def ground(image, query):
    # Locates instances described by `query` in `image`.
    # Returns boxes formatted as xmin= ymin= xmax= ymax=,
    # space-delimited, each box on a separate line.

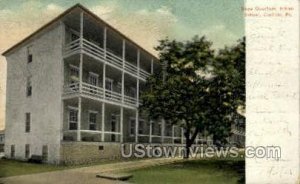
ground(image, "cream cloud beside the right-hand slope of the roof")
xmin=91 ymin=4 xmax=178 ymax=54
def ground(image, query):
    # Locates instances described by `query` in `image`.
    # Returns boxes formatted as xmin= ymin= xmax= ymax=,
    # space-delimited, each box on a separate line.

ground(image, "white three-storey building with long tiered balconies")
xmin=3 ymin=4 xmax=211 ymax=163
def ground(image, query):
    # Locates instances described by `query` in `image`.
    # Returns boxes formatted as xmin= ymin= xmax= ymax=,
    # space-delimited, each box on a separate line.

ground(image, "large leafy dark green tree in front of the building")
xmin=141 ymin=36 xmax=246 ymax=158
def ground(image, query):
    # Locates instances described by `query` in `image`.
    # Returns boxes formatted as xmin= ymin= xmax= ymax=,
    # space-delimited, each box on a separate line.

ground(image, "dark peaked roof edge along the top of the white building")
xmin=2 ymin=3 xmax=157 ymax=59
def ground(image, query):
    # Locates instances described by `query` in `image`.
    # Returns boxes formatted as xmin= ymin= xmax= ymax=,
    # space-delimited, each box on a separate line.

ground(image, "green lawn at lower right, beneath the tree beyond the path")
xmin=129 ymin=159 xmax=245 ymax=184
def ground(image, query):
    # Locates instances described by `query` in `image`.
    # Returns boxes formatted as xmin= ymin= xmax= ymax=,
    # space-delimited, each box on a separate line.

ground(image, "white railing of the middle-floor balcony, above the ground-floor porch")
xmin=64 ymin=82 xmax=137 ymax=107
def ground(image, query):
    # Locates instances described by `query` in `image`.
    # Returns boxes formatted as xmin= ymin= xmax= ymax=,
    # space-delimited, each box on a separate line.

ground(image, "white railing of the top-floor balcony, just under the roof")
xmin=64 ymin=39 xmax=150 ymax=80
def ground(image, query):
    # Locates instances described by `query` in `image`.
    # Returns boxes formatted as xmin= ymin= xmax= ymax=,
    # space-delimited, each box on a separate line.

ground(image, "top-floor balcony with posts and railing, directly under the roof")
xmin=63 ymin=11 xmax=161 ymax=81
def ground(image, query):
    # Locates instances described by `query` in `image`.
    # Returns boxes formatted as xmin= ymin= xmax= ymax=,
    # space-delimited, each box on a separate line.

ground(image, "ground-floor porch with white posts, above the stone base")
xmin=62 ymin=97 xmax=209 ymax=144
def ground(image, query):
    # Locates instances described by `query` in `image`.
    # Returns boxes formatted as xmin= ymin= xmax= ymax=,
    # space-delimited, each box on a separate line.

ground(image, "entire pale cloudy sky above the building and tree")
xmin=0 ymin=0 xmax=244 ymax=130
